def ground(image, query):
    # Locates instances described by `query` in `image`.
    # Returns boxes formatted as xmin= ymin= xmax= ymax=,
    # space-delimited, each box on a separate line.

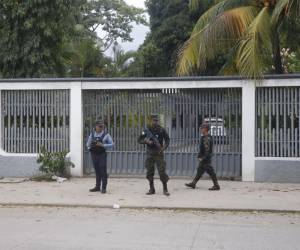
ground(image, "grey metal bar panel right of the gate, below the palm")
xmin=256 ymin=87 xmax=300 ymax=157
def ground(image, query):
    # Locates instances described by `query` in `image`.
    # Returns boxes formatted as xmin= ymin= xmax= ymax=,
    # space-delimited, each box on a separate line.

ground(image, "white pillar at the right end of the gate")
xmin=242 ymin=81 xmax=255 ymax=181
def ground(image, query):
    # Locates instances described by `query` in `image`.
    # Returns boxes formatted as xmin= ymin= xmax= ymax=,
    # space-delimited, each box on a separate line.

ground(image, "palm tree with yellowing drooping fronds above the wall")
xmin=177 ymin=0 xmax=300 ymax=79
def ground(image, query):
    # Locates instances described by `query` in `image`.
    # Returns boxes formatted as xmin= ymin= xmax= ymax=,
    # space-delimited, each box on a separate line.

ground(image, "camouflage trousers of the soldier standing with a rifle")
xmin=145 ymin=154 xmax=169 ymax=183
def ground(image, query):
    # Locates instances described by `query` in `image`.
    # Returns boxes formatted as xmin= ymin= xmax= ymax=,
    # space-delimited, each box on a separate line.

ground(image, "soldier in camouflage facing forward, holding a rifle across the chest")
xmin=138 ymin=115 xmax=170 ymax=196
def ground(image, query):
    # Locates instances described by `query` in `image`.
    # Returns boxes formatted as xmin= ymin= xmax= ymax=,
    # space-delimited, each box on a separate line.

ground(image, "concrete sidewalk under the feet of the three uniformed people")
xmin=0 ymin=178 xmax=300 ymax=212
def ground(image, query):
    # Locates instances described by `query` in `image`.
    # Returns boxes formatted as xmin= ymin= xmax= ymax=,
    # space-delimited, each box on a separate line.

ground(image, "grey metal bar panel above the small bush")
xmin=1 ymin=90 xmax=70 ymax=153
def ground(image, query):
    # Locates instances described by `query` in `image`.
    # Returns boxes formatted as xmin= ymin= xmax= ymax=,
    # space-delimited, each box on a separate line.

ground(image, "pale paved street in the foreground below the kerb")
xmin=0 ymin=207 xmax=300 ymax=250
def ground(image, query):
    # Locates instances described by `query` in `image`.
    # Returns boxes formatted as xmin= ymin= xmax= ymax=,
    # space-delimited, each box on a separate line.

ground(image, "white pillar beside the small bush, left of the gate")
xmin=70 ymin=82 xmax=83 ymax=176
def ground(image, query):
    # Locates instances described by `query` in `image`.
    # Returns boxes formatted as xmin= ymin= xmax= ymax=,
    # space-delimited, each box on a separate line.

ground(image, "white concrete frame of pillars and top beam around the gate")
xmin=0 ymin=76 xmax=300 ymax=181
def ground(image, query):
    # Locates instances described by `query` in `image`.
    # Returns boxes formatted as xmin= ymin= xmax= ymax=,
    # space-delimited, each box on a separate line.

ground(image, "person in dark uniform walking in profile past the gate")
xmin=185 ymin=123 xmax=220 ymax=191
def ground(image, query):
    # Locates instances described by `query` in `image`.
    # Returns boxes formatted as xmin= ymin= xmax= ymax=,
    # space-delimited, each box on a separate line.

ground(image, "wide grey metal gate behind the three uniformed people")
xmin=83 ymin=88 xmax=242 ymax=178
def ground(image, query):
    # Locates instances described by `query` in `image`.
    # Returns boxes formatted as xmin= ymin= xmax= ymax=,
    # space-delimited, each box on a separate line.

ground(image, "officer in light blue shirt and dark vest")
xmin=86 ymin=120 xmax=114 ymax=194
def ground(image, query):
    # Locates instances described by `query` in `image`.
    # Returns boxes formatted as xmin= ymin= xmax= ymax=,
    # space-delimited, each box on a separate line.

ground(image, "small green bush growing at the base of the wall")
xmin=37 ymin=148 xmax=74 ymax=177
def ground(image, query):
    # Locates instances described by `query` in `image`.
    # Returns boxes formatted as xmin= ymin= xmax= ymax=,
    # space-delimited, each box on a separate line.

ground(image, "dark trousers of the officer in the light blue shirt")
xmin=91 ymin=153 xmax=108 ymax=189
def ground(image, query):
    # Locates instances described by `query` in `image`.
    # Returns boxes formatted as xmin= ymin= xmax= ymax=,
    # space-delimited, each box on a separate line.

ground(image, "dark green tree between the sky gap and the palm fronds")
xmin=136 ymin=0 xmax=206 ymax=77
